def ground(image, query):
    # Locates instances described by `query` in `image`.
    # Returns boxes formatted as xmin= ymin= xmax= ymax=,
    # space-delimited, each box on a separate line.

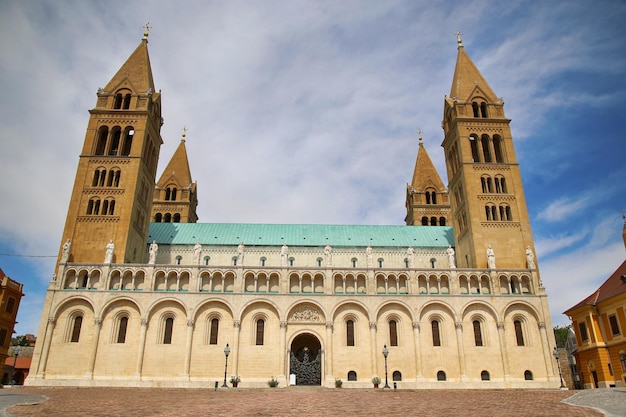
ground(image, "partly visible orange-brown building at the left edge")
xmin=0 ymin=269 xmax=24 ymax=376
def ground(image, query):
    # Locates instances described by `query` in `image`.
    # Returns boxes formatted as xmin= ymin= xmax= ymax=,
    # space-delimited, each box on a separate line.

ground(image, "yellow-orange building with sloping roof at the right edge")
xmin=564 ymin=219 xmax=626 ymax=388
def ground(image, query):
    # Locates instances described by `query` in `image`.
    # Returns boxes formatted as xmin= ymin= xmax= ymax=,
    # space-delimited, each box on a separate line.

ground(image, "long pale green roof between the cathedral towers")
xmin=148 ymin=223 xmax=454 ymax=248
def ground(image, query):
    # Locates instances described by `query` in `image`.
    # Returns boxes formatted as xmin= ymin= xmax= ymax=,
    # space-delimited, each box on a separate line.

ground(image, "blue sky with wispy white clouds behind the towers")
xmin=0 ymin=0 xmax=626 ymax=334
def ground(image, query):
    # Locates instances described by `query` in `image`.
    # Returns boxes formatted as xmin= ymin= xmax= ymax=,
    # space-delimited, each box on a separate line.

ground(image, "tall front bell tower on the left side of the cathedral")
xmin=59 ymin=30 xmax=163 ymax=263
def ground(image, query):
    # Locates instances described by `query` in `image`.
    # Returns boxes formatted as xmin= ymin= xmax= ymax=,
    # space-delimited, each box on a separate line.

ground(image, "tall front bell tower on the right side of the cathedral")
xmin=442 ymin=33 xmax=534 ymax=269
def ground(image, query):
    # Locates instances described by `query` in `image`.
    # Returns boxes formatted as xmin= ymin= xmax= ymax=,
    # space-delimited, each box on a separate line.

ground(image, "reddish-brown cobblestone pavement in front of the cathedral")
xmin=0 ymin=387 xmax=626 ymax=417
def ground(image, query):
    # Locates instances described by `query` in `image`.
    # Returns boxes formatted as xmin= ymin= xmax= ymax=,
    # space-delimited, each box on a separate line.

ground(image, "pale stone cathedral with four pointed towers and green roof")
xmin=26 ymin=33 xmax=559 ymax=389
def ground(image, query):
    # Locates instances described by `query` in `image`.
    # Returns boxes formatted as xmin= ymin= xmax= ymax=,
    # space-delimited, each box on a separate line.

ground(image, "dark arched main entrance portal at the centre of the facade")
xmin=289 ymin=333 xmax=322 ymax=385
